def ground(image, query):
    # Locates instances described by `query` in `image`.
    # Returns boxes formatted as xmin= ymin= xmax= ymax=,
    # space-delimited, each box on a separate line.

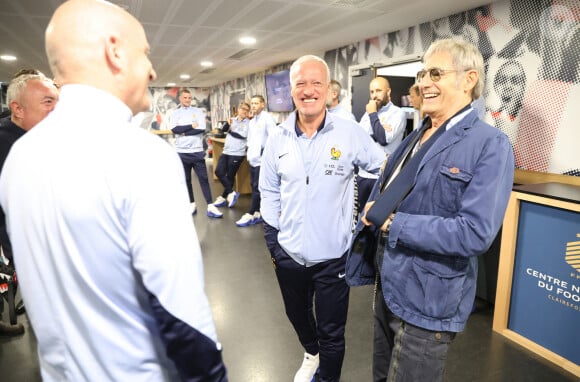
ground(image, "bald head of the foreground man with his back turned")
xmin=46 ymin=0 xmax=156 ymax=114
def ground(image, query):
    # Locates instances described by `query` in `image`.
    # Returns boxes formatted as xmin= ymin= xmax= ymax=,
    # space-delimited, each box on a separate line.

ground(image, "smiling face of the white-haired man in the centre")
xmin=291 ymin=61 xmax=330 ymax=120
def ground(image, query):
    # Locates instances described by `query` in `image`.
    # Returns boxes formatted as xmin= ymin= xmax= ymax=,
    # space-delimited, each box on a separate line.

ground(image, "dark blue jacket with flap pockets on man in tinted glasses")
xmin=347 ymin=110 xmax=514 ymax=332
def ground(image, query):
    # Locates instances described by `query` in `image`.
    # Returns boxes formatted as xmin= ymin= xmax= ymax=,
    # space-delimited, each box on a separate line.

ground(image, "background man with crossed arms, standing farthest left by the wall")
xmin=169 ymin=89 xmax=222 ymax=218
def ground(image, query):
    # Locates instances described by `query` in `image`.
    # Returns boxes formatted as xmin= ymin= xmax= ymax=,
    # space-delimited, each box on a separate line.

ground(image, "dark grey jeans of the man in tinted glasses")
xmin=373 ymin=283 xmax=456 ymax=382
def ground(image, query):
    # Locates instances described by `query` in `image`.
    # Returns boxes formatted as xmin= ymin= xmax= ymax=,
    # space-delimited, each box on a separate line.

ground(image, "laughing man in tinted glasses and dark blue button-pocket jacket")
xmin=347 ymin=39 xmax=514 ymax=381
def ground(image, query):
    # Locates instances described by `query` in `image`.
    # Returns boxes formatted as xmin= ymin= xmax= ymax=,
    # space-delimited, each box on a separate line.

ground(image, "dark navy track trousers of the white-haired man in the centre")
xmin=270 ymin=245 xmax=350 ymax=382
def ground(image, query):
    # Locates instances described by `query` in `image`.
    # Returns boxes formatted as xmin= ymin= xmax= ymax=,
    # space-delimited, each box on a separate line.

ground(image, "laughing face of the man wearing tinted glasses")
xmin=419 ymin=51 xmax=477 ymax=123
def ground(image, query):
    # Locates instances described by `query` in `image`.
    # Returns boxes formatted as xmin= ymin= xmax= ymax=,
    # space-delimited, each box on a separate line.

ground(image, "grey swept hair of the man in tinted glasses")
xmin=423 ymin=38 xmax=485 ymax=99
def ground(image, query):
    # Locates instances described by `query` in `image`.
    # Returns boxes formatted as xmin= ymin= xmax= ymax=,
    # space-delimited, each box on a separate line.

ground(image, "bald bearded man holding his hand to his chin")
xmin=356 ymin=77 xmax=407 ymax=215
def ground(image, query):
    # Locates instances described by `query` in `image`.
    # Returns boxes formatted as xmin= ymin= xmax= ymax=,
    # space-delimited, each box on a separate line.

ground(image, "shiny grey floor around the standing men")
xmin=0 ymin=163 xmax=578 ymax=382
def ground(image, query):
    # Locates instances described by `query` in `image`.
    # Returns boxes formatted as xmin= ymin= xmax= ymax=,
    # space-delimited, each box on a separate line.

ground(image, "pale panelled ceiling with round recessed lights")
xmin=0 ymin=0 xmax=492 ymax=87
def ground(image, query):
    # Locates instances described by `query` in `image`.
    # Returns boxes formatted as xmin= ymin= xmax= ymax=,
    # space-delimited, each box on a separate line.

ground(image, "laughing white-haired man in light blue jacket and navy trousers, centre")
xmin=260 ymin=55 xmax=385 ymax=382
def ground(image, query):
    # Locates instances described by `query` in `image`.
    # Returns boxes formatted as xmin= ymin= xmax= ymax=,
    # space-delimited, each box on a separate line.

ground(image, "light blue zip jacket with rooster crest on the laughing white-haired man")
xmin=260 ymin=113 xmax=385 ymax=266
